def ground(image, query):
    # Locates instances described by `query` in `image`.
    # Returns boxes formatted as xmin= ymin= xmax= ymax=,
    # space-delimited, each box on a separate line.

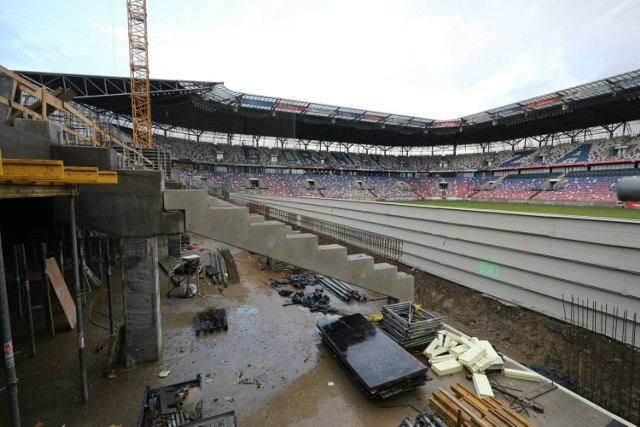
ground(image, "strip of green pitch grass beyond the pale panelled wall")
xmin=406 ymin=200 xmax=640 ymax=221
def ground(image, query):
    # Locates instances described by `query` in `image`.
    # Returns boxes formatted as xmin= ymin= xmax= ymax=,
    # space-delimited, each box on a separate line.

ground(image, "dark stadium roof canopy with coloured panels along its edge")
xmin=16 ymin=69 xmax=640 ymax=147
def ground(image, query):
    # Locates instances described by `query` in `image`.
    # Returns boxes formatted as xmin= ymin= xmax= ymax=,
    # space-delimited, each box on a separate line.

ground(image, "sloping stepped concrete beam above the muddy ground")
xmin=164 ymin=190 xmax=414 ymax=301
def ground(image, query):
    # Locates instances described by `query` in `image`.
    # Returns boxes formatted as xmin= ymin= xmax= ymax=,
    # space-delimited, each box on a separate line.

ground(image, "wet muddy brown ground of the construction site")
xmin=0 ymin=231 xmax=640 ymax=426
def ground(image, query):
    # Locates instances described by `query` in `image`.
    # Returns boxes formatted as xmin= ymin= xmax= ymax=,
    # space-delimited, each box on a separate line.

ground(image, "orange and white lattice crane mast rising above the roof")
xmin=127 ymin=0 xmax=153 ymax=148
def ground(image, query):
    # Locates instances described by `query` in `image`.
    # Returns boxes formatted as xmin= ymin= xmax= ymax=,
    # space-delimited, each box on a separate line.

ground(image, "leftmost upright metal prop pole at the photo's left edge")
xmin=0 ymin=236 xmax=20 ymax=427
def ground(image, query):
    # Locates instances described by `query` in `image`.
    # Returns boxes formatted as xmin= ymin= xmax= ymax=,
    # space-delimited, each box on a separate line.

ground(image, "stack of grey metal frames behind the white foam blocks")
xmin=379 ymin=302 xmax=442 ymax=349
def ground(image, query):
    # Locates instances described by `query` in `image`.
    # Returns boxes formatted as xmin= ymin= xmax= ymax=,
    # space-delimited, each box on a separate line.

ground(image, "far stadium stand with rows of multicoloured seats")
xmin=166 ymin=135 xmax=640 ymax=203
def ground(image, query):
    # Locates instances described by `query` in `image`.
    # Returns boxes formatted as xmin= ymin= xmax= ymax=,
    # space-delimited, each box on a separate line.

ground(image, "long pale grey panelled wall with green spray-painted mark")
xmin=237 ymin=195 xmax=640 ymax=342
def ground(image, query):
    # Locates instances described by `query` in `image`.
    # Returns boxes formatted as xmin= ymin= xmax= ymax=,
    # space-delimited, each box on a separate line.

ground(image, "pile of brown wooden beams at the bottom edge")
xmin=429 ymin=384 xmax=533 ymax=427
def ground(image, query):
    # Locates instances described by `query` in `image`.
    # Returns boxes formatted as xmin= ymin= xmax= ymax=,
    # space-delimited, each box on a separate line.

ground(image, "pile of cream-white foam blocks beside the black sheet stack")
xmin=422 ymin=330 xmax=504 ymax=375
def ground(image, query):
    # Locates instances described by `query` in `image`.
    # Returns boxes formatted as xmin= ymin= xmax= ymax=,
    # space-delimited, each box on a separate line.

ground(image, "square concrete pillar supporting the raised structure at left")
xmin=121 ymin=237 xmax=162 ymax=367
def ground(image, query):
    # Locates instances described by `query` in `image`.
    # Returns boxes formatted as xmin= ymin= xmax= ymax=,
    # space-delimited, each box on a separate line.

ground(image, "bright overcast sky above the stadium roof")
xmin=0 ymin=0 xmax=640 ymax=119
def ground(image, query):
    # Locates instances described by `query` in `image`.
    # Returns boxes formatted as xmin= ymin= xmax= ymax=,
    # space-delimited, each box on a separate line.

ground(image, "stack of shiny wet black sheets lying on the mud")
xmin=317 ymin=313 xmax=429 ymax=399
